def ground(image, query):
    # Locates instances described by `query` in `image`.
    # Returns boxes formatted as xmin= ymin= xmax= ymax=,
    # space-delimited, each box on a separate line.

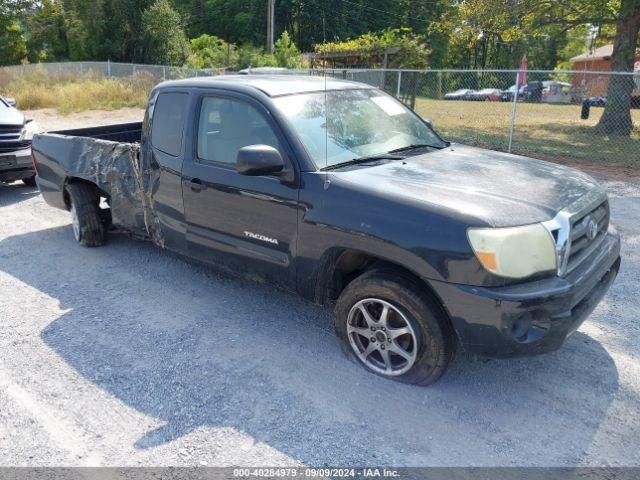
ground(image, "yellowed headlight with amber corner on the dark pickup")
xmin=467 ymin=223 xmax=557 ymax=278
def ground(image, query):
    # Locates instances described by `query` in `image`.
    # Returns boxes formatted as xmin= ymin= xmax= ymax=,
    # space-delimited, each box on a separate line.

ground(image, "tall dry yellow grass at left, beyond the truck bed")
xmin=0 ymin=69 xmax=158 ymax=114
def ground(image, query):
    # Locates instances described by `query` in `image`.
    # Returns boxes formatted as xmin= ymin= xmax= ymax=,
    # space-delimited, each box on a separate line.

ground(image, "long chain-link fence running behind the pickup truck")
xmin=0 ymin=62 xmax=640 ymax=167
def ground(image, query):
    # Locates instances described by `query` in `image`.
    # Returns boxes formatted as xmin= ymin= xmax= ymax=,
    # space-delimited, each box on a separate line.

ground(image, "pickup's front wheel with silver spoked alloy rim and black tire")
xmin=334 ymin=269 xmax=456 ymax=385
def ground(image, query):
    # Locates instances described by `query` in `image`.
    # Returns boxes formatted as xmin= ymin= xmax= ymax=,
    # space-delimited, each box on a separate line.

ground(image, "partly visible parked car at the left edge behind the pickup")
xmin=0 ymin=97 xmax=38 ymax=187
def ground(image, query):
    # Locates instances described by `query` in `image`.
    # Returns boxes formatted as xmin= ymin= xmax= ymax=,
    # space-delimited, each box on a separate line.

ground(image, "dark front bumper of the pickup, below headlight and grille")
xmin=433 ymin=232 xmax=620 ymax=358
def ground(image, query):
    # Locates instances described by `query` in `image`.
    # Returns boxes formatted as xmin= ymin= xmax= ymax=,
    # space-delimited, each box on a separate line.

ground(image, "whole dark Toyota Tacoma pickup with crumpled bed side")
xmin=33 ymin=76 xmax=620 ymax=385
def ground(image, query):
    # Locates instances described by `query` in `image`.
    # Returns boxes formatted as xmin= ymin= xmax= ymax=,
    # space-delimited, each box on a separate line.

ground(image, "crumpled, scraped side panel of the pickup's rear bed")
xmin=33 ymin=123 xmax=163 ymax=246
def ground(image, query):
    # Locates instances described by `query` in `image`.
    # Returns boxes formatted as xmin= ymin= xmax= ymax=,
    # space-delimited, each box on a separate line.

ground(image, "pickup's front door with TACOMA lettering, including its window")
xmin=182 ymin=95 xmax=298 ymax=288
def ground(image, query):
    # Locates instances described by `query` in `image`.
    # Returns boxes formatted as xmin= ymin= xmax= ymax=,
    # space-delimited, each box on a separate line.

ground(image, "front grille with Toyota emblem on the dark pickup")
xmin=566 ymin=200 xmax=609 ymax=273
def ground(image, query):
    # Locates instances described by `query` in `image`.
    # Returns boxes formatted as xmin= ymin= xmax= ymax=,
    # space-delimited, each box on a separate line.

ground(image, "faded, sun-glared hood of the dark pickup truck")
xmin=336 ymin=144 xmax=600 ymax=227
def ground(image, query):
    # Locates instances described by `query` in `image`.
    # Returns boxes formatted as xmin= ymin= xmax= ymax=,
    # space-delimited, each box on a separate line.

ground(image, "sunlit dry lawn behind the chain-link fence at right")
xmin=416 ymin=98 xmax=640 ymax=168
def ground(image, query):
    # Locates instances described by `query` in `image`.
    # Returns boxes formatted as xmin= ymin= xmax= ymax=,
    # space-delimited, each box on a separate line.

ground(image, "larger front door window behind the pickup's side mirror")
xmin=198 ymin=97 xmax=282 ymax=164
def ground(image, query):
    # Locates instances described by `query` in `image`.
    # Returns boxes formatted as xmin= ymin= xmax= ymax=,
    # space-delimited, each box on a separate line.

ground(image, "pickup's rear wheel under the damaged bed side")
xmin=67 ymin=183 xmax=105 ymax=247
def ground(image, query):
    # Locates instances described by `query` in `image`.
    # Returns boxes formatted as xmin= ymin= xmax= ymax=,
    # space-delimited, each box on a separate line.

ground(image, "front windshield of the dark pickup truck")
xmin=274 ymin=89 xmax=446 ymax=168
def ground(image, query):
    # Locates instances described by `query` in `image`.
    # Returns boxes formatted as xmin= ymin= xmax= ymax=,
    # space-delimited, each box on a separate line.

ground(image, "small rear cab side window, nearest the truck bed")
xmin=151 ymin=93 xmax=189 ymax=157
